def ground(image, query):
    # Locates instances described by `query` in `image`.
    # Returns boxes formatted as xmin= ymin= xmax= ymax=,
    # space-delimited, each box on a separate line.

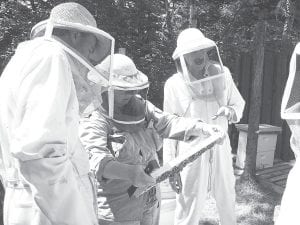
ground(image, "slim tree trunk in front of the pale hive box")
xmin=242 ymin=19 xmax=266 ymax=180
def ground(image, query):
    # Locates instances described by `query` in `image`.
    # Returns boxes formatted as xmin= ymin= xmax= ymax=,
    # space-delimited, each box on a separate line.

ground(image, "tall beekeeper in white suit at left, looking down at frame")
xmin=0 ymin=2 xmax=114 ymax=225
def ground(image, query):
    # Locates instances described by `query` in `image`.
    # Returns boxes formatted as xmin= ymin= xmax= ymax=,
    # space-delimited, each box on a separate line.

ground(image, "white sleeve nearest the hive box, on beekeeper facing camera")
xmin=226 ymin=68 xmax=245 ymax=123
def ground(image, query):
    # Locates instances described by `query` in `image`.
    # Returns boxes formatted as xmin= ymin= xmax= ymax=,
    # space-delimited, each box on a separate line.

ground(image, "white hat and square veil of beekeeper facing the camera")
xmin=172 ymin=28 xmax=225 ymax=100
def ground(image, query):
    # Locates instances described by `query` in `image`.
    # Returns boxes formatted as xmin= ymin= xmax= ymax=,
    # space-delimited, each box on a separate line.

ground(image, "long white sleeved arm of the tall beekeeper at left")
xmin=11 ymin=51 xmax=92 ymax=225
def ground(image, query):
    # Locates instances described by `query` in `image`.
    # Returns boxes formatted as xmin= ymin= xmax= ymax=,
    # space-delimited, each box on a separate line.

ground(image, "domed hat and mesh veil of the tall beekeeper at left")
xmin=30 ymin=3 xmax=115 ymax=114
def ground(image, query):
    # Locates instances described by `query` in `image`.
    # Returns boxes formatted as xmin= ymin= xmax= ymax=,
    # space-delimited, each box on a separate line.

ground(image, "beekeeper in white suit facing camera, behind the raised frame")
xmin=163 ymin=28 xmax=245 ymax=225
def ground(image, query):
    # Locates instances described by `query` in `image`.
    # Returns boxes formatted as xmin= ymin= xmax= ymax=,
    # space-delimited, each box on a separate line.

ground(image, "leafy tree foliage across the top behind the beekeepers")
xmin=0 ymin=0 xmax=300 ymax=107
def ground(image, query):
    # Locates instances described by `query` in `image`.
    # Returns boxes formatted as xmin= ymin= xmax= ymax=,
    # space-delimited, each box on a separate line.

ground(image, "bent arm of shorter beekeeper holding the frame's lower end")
xmin=80 ymin=110 xmax=155 ymax=187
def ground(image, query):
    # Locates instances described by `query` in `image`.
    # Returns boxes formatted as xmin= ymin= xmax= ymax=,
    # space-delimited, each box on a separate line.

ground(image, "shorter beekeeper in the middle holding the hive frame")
xmin=80 ymin=54 xmax=224 ymax=225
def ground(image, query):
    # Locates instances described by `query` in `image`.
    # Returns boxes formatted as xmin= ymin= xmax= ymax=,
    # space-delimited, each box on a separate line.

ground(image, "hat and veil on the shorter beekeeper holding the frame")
xmin=88 ymin=54 xmax=149 ymax=130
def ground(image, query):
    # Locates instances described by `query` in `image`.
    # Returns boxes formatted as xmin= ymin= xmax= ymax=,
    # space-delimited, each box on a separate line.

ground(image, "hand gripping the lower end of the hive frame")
xmin=129 ymin=165 xmax=156 ymax=187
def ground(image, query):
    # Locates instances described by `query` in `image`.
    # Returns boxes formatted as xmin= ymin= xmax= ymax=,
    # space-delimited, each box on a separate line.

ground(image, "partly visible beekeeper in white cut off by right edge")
xmin=275 ymin=43 xmax=300 ymax=225
